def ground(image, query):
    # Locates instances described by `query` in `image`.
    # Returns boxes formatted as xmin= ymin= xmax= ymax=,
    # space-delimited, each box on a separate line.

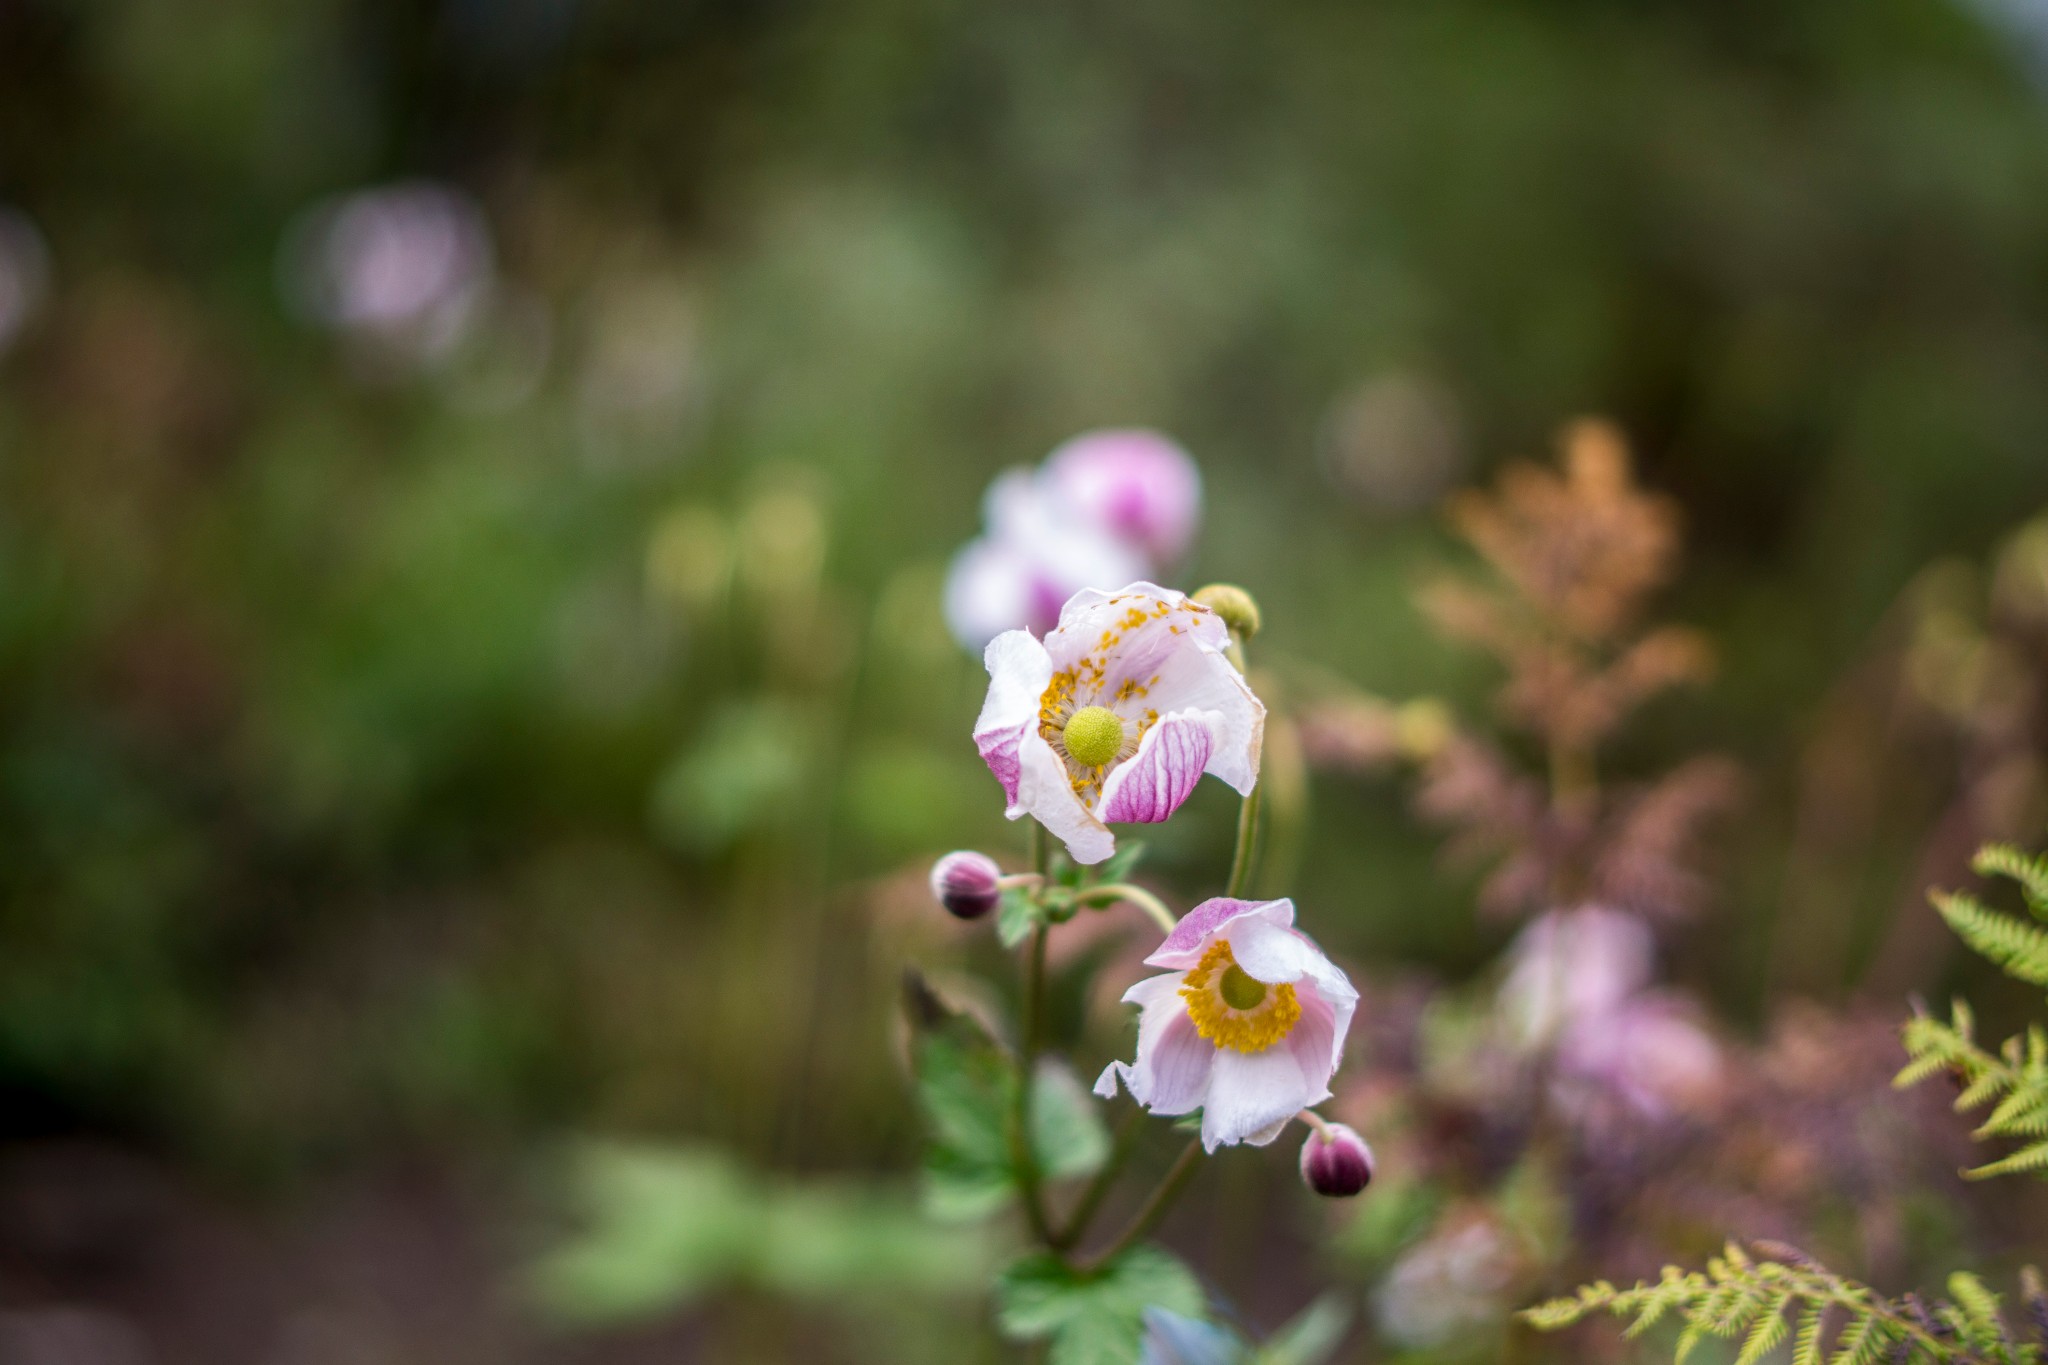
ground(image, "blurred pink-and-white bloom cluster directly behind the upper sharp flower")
xmin=946 ymin=428 xmax=1202 ymax=651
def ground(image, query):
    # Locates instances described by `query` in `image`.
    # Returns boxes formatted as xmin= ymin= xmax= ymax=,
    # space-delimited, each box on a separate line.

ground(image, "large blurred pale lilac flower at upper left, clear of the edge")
xmin=283 ymin=180 xmax=492 ymax=362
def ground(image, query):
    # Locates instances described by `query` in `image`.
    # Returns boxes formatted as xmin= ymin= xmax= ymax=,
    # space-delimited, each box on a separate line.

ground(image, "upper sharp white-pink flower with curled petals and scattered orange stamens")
xmin=975 ymin=583 xmax=1266 ymax=864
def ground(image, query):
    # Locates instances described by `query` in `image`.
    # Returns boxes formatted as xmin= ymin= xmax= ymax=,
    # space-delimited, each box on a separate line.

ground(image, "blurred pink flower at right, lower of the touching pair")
xmin=1552 ymin=993 xmax=1722 ymax=1121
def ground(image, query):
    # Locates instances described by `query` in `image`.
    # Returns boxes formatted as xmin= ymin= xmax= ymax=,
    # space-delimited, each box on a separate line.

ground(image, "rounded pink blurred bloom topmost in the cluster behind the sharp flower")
xmin=1042 ymin=428 xmax=1202 ymax=571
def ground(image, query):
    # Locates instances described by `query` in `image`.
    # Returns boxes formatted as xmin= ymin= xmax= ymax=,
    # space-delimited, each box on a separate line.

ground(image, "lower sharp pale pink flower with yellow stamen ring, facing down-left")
xmin=1096 ymin=898 xmax=1358 ymax=1152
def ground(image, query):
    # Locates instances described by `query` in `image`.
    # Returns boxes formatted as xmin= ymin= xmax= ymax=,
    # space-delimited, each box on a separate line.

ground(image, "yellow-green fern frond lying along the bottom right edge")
xmin=1522 ymin=1244 xmax=2048 ymax=1365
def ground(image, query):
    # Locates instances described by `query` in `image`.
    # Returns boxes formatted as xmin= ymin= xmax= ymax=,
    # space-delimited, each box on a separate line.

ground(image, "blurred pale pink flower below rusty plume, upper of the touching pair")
xmin=1499 ymin=905 xmax=1655 ymax=1048
